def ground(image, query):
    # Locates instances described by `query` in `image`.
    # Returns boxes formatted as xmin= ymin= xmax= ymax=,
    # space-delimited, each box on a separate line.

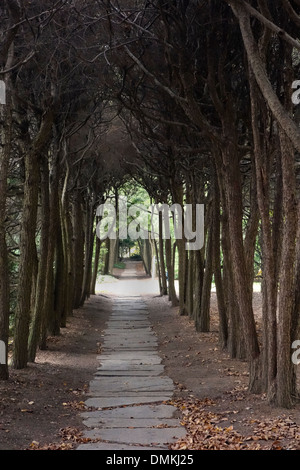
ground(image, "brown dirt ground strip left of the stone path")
xmin=0 ymin=295 xmax=111 ymax=450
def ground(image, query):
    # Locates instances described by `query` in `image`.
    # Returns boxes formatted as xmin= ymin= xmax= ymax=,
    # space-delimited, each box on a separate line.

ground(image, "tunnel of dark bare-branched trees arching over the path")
xmin=0 ymin=0 xmax=300 ymax=408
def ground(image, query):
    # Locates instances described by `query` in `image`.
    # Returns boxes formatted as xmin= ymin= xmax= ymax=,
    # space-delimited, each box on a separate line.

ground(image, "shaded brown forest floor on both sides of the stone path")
xmin=0 ymin=262 xmax=300 ymax=450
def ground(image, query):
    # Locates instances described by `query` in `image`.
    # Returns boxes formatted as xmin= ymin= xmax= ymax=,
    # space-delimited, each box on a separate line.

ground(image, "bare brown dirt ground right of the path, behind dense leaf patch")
xmin=147 ymin=293 xmax=300 ymax=450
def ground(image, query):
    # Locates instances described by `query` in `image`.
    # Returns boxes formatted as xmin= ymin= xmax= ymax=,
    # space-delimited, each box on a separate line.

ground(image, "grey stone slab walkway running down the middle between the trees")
xmin=78 ymin=265 xmax=186 ymax=450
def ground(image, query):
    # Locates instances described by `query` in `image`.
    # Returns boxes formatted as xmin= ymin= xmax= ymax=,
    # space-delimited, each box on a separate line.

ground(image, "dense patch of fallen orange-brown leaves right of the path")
xmin=170 ymin=398 xmax=300 ymax=450
